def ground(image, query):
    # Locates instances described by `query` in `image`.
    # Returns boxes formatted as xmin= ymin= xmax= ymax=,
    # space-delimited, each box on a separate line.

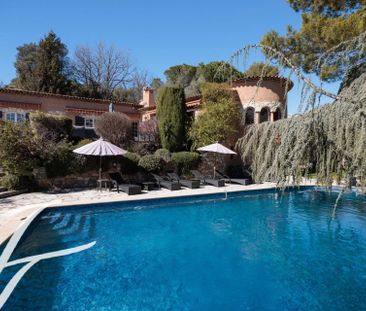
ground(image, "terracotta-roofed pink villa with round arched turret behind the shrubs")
xmin=0 ymin=76 xmax=293 ymax=138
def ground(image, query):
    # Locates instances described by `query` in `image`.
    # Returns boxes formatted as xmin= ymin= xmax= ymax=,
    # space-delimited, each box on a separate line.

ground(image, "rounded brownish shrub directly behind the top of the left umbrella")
xmin=95 ymin=112 xmax=132 ymax=147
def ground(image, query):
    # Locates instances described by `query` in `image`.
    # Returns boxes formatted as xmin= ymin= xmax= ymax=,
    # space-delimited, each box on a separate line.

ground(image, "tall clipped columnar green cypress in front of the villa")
xmin=157 ymin=86 xmax=188 ymax=151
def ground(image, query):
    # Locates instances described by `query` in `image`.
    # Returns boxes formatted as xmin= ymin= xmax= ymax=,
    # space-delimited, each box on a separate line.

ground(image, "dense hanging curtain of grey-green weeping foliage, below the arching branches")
xmin=236 ymin=91 xmax=366 ymax=187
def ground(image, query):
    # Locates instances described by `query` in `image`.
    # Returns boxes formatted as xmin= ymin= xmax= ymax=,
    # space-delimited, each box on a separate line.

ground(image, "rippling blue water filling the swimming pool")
xmin=0 ymin=190 xmax=366 ymax=311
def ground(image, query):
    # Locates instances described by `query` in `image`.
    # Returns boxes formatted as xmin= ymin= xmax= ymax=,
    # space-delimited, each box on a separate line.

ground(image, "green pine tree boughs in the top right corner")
xmin=261 ymin=0 xmax=366 ymax=81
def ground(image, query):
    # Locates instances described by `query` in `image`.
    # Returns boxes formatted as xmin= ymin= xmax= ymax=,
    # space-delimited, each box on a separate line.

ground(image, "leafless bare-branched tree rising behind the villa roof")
xmin=73 ymin=43 xmax=135 ymax=99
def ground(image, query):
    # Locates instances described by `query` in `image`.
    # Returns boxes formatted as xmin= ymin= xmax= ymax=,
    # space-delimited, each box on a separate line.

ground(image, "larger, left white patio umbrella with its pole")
xmin=73 ymin=138 xmax=127 ymax=179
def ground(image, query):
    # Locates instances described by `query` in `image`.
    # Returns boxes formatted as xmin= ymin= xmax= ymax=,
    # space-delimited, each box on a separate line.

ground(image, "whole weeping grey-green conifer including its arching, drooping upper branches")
xmin=220 ymin=33 xmax=366 ymax=193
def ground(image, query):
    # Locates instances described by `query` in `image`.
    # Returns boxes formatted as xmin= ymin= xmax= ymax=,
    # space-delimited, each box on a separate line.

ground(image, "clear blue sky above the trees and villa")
xmin=0 ymin=0 xmax=338 ymax=113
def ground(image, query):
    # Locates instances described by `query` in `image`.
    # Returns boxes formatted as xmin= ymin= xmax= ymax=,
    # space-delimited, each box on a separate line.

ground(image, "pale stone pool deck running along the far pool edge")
xmin=0 ymin=183 xmax=312 ymax=244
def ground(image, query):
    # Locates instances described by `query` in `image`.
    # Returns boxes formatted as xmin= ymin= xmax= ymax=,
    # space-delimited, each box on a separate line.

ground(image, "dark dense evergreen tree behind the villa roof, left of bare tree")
xmin=11 ymin=31 xmax=70 ymax=94
